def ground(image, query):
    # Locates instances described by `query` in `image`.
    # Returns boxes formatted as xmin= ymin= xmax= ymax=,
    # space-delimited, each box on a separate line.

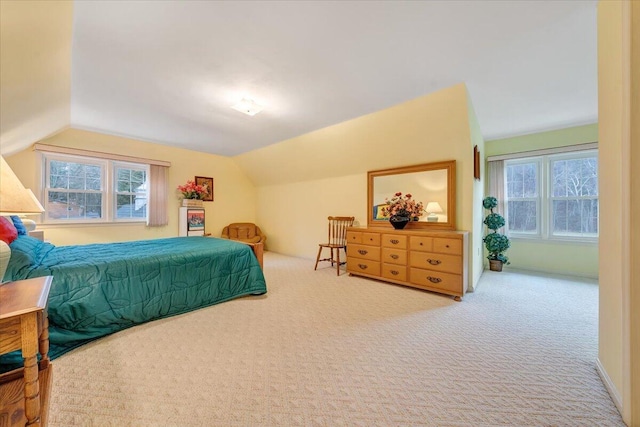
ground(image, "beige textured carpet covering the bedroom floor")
xmin=49 ymin=252 xmax=624 ymax=427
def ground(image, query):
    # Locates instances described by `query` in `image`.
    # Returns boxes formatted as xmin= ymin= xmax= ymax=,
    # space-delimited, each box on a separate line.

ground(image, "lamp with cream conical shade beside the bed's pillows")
xmin=0 ymin=156 xmax=44 ymax=282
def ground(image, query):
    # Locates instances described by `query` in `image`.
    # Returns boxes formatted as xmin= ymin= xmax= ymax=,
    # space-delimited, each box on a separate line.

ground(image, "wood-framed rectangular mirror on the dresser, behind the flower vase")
xmin=367 ymin=160 xmax=456 ymax=230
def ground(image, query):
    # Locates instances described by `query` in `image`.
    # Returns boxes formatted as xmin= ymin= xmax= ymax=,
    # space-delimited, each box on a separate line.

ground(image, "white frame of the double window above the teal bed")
xmin=40 ymin=152 xmax=150 ymax=225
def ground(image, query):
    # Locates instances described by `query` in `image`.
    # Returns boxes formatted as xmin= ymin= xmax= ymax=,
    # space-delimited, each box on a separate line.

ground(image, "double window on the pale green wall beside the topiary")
xmin=504 ymin=150 xmax=598 ymax=240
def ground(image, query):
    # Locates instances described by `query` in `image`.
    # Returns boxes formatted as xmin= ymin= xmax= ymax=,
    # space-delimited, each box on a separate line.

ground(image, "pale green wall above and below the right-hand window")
xmin=485 ymin=124 xmax=605 ymax=278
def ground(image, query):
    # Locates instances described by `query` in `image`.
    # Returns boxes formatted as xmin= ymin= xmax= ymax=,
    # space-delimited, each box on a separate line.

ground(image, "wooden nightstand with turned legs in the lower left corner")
xmin=0 ymin=276 xmax=53 ymax=427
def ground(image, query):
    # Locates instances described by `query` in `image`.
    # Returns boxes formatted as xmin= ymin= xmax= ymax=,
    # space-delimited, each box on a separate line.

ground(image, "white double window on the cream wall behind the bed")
xmin=44 ymin=154 xmax=149 ymax=223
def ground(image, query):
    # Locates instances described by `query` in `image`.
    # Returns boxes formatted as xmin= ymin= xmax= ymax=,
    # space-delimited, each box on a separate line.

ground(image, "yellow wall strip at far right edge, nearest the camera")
xmin=598 ymin=1 xmax=640 ymax=426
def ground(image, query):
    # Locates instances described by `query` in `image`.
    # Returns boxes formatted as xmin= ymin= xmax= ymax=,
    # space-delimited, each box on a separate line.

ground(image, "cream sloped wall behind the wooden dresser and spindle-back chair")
xmin=234 ymin=84 xmax=479 ymax=285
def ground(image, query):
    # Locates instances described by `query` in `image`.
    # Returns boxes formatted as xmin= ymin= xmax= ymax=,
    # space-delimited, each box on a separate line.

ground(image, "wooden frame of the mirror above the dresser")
xmin=367 ymin=160 xmax=457 ymax=230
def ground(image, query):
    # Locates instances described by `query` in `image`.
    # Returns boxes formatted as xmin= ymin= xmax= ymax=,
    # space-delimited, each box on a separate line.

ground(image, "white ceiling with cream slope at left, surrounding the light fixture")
xmin=0 ymin=0 xmax=597 ymax=155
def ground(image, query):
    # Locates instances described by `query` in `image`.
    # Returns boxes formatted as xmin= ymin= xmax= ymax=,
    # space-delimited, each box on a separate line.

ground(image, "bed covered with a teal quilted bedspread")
xmin=0 ymin=235 xmax=267 ymax=372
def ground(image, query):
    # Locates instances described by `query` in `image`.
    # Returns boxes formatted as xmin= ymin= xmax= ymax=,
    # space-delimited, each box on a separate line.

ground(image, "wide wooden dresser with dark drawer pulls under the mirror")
xmin=347 ymin=226 xmax=469 ymax=301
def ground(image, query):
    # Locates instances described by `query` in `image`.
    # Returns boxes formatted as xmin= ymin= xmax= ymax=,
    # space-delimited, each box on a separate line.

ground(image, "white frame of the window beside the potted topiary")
xmin=503 ymin=148 xmax=600 ymax=244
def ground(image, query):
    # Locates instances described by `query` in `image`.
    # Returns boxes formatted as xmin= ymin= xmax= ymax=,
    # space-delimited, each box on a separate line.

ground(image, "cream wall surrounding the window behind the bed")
xmin=6 ymin=129 xmax=256 ymax=245
